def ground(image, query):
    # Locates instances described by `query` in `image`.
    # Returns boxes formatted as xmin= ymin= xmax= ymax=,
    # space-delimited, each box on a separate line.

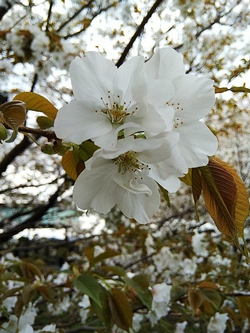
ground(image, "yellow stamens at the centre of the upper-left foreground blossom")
xmin=96 ymin=90 xmax=138 ymax=124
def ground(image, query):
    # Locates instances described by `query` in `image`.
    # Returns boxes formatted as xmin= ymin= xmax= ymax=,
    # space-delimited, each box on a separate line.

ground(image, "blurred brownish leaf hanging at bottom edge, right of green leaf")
xmin=109 ymin=288 xmax=133 ymax=332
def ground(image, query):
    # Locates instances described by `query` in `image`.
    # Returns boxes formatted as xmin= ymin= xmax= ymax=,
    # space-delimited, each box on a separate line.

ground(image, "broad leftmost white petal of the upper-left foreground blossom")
xmin=54 ymin=100 xmax=112 ymax=144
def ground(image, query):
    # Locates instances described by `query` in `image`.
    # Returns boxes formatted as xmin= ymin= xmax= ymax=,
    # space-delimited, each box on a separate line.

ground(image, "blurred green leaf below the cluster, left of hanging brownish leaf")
xmin=73 ymin=274 xmax=101 ymax=306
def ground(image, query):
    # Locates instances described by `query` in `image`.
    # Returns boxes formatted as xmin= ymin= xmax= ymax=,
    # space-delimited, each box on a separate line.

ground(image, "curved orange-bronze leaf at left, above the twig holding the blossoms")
xmin=14 ymin=92 xmax=58 ymax=120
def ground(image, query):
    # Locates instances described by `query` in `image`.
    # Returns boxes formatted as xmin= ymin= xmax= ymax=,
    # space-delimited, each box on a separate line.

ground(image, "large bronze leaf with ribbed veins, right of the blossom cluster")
xmin=200 ymin=158 xmax=249 ymax=246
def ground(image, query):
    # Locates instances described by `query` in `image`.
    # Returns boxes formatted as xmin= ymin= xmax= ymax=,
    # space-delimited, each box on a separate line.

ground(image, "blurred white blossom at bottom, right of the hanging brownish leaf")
xmin=149 ymin=283 xmax=172 ymax=325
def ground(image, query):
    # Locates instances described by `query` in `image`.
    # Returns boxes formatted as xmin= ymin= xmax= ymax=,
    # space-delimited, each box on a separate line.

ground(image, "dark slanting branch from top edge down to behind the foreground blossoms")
xmin=116 ymin=0 xmax=164 ymax=67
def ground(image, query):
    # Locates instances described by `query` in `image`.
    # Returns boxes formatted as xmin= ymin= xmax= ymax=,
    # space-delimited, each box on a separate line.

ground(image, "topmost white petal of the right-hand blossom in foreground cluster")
xmin=145 ymin=47 xmax=185 ymax=81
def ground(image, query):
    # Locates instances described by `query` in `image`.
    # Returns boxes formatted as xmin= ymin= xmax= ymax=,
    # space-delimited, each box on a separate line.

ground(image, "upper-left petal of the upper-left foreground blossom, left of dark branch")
xmin=70 ymin=51 xmax=117 ymax=102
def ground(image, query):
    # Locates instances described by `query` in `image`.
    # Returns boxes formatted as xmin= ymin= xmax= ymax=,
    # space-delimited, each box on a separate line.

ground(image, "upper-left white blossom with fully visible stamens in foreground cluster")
xmin=55 ymin=52 xmax=168 ymax=150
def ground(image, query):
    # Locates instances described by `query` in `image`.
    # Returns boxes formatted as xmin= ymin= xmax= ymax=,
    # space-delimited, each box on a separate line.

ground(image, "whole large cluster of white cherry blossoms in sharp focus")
xmin=55 ymin=47 xmax=217 ymax=223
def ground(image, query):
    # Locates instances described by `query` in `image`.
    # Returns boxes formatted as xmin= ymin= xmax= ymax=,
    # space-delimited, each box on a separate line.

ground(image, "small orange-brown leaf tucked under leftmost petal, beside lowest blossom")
xmin=62 ymin=150 xmax=84 ymax=180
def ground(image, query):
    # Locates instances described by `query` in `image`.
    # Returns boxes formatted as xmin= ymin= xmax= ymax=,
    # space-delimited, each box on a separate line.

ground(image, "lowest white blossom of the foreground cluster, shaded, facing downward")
xmin=73 ymin=137 xmax=177 ymax=223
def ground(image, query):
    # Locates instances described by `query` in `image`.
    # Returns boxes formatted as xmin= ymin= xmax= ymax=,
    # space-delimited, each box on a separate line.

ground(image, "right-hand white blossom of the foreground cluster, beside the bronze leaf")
xmin=145 ymin=48 xmax=218 ymax=173
